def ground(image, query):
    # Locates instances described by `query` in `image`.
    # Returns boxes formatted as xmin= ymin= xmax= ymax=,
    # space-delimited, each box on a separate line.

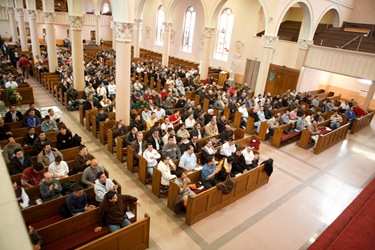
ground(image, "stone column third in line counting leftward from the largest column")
xmin=43 ymin=12 xmax=58 ymax=73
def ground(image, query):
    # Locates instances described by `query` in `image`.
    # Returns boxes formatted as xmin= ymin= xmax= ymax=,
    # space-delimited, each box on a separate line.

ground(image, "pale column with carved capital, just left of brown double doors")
xmin=255 ymin=35 xmax=278 ymax=95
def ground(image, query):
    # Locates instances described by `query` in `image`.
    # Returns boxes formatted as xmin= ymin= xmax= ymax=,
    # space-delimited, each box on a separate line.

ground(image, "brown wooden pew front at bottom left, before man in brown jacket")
xmin=76 ymin=214 xmax=150 ymax=250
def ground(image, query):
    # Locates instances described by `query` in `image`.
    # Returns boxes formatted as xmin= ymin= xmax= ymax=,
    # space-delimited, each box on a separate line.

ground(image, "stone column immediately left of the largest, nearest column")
xmin=69 ymin=16 xmax=85 ymax=91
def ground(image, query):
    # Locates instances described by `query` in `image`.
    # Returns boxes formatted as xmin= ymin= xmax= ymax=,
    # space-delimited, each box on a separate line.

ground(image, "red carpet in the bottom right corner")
xmin=308 ymin=179 xmax=375 ymax=250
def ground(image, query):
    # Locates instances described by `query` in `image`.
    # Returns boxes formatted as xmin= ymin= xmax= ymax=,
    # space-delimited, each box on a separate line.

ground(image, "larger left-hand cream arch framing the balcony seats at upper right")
xmin=274 ymin=0 xmax=314 ymax=40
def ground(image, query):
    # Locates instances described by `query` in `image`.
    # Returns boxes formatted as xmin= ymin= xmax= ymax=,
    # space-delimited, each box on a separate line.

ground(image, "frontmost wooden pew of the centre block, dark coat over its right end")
xmin=167 ymin=165 xmax=269 ymax=226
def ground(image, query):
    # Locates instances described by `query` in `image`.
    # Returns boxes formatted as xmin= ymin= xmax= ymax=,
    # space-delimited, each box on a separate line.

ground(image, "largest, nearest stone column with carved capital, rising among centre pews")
xmin=113 ymin=22 xmax=133 ymax=125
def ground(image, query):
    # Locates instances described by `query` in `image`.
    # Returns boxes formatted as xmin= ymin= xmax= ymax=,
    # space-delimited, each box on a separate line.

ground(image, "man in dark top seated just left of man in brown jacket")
xmin=66 ymin=185 xmax=95 ymax=216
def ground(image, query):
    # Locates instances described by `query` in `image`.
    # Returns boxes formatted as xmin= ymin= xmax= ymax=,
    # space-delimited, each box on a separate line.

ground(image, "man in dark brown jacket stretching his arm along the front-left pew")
xmin=95 ymin=191 xmax=141 ymax=232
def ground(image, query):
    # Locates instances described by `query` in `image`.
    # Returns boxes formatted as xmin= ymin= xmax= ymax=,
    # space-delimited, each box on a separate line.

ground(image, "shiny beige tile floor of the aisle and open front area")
xmin=0 ymin=76 xmax=375 ymax=250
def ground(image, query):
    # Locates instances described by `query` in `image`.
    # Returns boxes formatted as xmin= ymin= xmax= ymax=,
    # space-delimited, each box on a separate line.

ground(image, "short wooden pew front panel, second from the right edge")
xmin=314 ymin=123 xmax=350 ymax=154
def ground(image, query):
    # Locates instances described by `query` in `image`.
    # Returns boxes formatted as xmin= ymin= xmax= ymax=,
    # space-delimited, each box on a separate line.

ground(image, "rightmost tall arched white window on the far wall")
xmin=215 ymin=9 xmax=234 ymax=61
